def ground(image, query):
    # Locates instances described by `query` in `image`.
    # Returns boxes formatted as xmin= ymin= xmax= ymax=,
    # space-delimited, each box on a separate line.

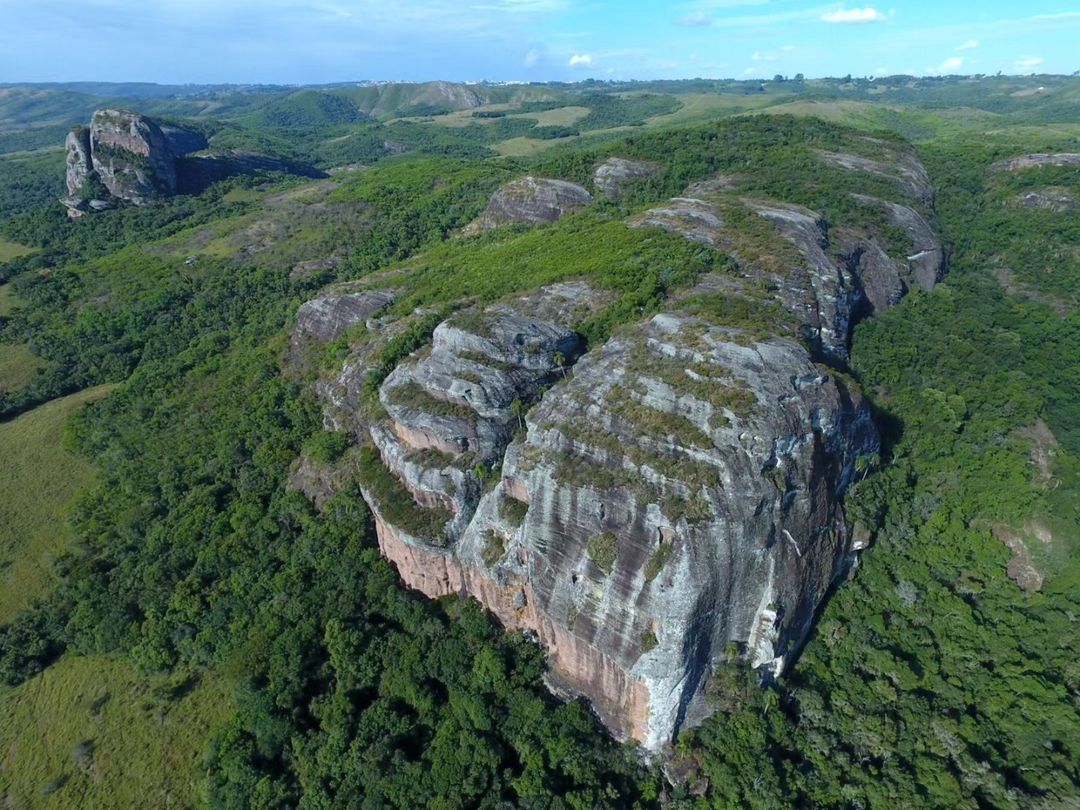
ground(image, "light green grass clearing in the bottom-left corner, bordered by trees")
xmin=0 ymin=656 xmax=232 ymax=810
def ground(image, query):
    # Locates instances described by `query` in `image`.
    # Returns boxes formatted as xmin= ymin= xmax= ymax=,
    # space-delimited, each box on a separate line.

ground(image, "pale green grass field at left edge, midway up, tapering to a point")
xmin=0 ymin=386 xmax=112 ymax=622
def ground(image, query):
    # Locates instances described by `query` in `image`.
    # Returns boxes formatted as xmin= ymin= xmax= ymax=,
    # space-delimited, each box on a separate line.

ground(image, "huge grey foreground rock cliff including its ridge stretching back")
xmin=298 ymin=144 xmax=945 ymax=751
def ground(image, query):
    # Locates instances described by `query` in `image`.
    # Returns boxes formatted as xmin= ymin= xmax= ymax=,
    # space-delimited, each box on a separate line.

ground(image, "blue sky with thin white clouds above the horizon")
xmin=0 ymin=0 xmax=1080 ymax=83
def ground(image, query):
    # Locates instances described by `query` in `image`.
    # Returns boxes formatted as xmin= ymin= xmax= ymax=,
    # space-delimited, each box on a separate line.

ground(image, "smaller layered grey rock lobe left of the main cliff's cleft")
xmin=369 ymin=285 xmax=603 ymax=545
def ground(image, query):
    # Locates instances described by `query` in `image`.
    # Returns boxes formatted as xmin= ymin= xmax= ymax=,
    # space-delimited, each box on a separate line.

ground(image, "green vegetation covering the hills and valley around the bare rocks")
xmin=0 ymin=79 xmax=1080 ymax=810
